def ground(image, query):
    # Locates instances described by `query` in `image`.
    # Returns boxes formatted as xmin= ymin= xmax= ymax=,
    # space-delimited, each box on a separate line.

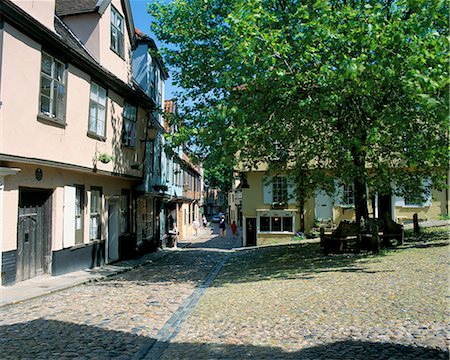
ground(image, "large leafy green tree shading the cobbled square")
xmin=149 ymin=0 xmax=449 ymax=219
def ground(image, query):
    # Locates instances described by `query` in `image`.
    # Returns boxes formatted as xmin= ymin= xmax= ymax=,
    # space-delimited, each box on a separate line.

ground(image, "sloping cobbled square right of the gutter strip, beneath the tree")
xmin=163 ymin=228 xmax=449 ymax=360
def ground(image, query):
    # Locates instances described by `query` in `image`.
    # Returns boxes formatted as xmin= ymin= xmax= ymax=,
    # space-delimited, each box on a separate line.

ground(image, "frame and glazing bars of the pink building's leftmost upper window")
xmin=38 ymin=51 xmax=68 ymax=126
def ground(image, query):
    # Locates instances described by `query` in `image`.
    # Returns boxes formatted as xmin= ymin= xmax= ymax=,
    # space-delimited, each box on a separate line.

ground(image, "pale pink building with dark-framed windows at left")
xmin=0 ymin=0 xmax=157 ymax=285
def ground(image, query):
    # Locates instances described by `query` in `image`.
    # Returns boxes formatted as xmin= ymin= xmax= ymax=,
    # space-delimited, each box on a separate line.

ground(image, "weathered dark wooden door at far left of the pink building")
xmin=16 ymin=188 xmax=53 ymax=281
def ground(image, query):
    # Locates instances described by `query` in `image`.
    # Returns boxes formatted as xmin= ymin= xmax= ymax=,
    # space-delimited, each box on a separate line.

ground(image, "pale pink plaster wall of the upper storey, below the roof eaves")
xmin=0 ymin=24 xmax=146 ymax=176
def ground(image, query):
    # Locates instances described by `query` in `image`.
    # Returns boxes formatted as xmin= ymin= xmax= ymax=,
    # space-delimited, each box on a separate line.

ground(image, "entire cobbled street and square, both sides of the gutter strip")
xmin=0 ymin=226 xmax=449 ymax=360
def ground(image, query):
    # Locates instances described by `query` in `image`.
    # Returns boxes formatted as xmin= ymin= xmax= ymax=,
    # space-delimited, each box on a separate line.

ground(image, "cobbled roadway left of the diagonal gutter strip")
xmin=0 ymin=226 xmax=231 ymax=360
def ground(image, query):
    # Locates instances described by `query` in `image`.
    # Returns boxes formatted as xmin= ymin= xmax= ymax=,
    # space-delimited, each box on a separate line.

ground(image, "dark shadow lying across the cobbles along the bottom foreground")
xmin=0 ymin=319 xmax=449 ymax=360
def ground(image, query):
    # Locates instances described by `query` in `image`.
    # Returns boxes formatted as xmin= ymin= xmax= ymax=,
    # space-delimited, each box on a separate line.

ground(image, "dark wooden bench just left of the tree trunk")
xmin=320 ymin=220 xmax=361 ymax=254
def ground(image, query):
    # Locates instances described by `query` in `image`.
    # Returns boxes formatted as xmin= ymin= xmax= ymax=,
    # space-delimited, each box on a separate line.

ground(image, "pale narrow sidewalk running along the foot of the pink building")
xmin=0 ymin=238 xmax=191 ymax=307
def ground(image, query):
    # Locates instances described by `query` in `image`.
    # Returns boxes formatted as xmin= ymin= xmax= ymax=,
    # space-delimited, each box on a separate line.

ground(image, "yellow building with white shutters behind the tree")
xmin=237 ymin=167 xmax=449 ymax=246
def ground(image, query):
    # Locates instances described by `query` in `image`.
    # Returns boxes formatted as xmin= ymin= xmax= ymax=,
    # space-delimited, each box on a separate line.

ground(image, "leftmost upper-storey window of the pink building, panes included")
xmin=39 ymin=53 xmax=66 ymax=122
